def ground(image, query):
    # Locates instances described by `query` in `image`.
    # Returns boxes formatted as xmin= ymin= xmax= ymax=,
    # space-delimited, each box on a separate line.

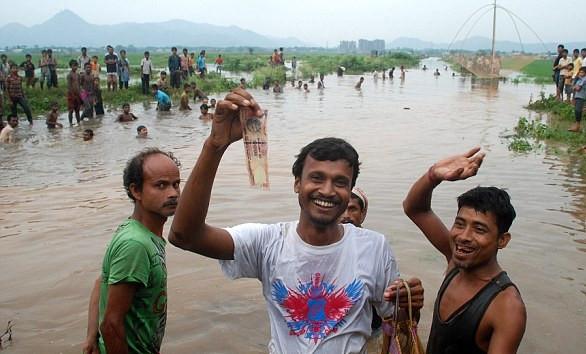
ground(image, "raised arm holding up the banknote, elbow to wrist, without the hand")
xmin=169 ymin=138 xmax=234 ymax=259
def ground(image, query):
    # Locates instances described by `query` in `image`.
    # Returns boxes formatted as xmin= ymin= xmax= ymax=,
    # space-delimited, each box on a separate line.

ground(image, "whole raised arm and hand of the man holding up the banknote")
xmin=169 ymin=89 xmax=262 ymax=259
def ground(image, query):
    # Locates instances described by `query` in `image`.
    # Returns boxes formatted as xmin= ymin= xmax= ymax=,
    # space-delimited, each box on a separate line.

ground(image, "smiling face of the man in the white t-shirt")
xmin=294 ymin=155 xmax=353 ymax=228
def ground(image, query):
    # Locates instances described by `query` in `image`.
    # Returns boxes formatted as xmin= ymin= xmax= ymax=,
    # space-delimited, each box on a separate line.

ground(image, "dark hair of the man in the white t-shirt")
xmin=292 ymin=138 xmax=360 ymax=187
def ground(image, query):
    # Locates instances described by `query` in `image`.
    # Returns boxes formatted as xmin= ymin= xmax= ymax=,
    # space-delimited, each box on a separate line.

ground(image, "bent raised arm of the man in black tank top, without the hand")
xmin=403 ymin=172 xmax=452 ymax=261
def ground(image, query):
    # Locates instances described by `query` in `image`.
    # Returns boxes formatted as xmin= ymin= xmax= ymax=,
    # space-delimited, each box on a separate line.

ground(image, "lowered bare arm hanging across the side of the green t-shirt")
xmin=100 ymin=283 xmax=137 ymax=354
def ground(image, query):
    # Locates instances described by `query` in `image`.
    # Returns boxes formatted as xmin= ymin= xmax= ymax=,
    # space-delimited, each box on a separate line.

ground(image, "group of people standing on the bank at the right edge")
xmin=552 ymin=44 xmax=586 ymax=133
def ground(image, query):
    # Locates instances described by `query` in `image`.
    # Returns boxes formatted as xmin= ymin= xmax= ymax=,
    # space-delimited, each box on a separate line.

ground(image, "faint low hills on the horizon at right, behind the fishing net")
xmin=387 ymin=37 xmax=586 ymax=53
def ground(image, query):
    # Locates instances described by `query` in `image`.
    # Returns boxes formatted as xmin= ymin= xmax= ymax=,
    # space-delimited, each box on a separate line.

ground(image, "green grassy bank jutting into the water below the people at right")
xmin=509 ymin=93 xmax=586 ymax=157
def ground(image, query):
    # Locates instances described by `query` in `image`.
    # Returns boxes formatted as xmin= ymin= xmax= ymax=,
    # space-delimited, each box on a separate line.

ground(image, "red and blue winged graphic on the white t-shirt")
xmin=272 ymin=273 xmax=364 ymax=344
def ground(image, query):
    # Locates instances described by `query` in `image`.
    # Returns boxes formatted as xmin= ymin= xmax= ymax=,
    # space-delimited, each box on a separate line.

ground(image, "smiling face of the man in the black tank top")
xmin=450 ymin=206 xmax=511 ymax=270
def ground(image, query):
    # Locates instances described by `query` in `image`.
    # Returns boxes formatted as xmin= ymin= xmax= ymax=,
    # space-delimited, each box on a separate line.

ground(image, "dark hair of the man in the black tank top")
xmin=458 ymin=187 xmax=517 ymax=235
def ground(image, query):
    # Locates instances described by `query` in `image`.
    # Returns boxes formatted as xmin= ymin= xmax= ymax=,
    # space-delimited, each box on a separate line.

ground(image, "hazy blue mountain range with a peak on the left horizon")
xmin=0 ymin=10 xmax=308 ymax=48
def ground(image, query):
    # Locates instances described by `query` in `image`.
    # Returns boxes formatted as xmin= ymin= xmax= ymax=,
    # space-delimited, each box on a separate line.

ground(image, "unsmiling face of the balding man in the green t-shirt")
xmin=130 ymin=154 xmax=181 ymax=218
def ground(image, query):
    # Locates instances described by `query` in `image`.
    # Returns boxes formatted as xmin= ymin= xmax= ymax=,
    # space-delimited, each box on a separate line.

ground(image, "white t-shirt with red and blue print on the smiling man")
xmin=220 ymin=222 xmax=399 ymax=354
